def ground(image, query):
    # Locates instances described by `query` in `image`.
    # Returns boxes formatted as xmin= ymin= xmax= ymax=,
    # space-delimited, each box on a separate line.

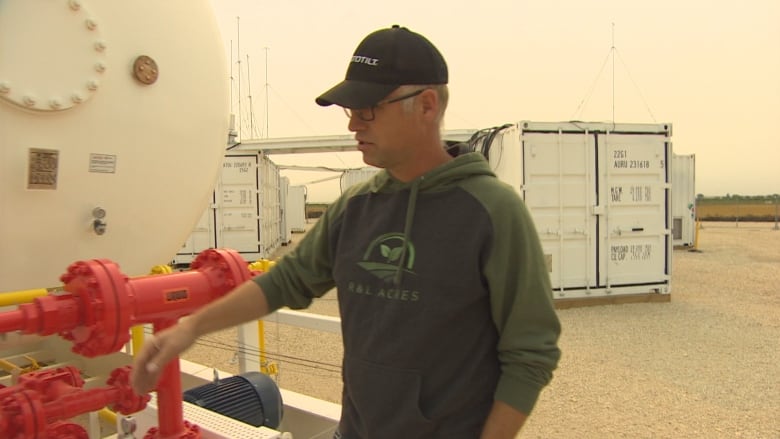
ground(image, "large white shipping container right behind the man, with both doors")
xmin=478 ymin=121 xmax=672 ymax=299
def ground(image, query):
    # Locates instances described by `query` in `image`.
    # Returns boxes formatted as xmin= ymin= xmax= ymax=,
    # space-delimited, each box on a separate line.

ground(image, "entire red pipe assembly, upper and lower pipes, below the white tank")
xmin=0 ymin=249 xmax=257 ymax=439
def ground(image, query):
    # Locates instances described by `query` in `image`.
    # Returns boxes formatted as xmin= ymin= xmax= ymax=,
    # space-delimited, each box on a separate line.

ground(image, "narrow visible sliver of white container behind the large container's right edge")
xmin=672 ymin=154 xmax=696 ymax=247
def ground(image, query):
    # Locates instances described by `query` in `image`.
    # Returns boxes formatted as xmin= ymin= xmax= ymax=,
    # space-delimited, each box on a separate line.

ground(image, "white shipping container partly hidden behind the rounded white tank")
xmin=173 ymin=152 xmax=282 ymax=266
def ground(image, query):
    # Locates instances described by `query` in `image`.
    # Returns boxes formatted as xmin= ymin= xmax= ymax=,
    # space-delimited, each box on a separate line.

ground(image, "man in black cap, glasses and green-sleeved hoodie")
xmin=132 ymin=26 xmax=560 ymax=439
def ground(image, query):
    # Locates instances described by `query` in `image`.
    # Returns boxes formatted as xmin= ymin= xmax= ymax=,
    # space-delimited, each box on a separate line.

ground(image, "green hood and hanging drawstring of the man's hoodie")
xmin=360 ymin=153 xmax=495 ymax=286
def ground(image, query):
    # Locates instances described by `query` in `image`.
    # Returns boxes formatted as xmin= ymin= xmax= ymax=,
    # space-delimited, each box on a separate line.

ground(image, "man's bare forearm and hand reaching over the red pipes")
xmin=130 ymin=280 xmax=269 ymax=395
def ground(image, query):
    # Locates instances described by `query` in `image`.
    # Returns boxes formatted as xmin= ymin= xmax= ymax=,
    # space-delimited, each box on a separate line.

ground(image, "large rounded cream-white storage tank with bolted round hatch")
xmin=0 ymin=0 xmax=230 ymax=292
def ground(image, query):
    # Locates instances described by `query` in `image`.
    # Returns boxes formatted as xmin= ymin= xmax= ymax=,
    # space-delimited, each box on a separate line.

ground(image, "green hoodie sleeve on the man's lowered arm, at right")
xmin=472 ymin=179 xmax=561 ymax=414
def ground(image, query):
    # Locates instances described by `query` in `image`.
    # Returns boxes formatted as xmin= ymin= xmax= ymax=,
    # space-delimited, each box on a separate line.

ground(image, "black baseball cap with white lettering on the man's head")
xmin=316 ymin=24 xmax=448 ymax=108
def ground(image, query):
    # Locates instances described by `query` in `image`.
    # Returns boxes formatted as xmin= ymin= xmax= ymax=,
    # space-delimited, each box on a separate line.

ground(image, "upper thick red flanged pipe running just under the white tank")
xmin=0 ymin=249 xmax=253 ymax=357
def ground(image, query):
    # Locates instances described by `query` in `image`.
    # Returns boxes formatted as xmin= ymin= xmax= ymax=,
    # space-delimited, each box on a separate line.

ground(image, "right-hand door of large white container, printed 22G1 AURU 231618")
xmin=597 ymin=133 xmax=671 ymax=291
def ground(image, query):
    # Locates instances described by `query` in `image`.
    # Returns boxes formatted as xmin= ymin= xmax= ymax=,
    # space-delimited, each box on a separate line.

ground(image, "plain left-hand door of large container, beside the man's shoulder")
xmin=520 ymin=132 xmax=597 ymax=298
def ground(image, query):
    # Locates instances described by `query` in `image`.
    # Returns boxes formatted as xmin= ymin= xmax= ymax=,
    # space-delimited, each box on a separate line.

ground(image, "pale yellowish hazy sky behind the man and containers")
xmin=212 ymin=0 xmax=780 ymax=201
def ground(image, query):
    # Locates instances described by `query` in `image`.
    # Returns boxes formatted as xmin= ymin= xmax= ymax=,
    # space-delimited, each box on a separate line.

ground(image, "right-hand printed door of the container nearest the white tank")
xmin=216 ymin=155 xmax=261 ymax=262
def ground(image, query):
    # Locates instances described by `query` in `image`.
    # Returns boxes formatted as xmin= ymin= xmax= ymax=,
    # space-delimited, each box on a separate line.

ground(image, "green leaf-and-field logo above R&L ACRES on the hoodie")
xmin=358 ymin=233 xmax=415 ymax=283
